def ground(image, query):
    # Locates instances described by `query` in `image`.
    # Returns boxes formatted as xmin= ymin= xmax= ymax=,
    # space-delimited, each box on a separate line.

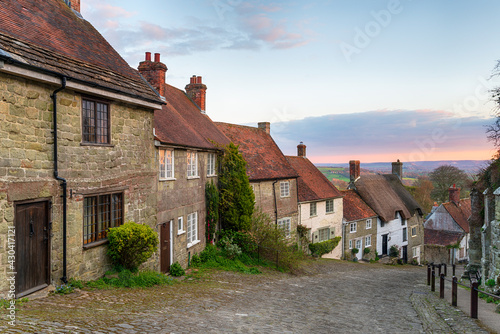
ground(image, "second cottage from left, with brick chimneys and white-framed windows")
xmin=138 ymin=52 xmax=230 ymax=272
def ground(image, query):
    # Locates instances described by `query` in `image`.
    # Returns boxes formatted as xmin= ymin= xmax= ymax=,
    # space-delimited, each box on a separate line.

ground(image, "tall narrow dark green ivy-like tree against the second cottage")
xmin=219 ymin=143 xmax=255 ymax=231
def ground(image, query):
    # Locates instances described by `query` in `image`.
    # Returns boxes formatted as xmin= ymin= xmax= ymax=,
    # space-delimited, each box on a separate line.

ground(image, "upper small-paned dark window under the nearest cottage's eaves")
xmin=82 ymin=99 xmax=110 ymax=144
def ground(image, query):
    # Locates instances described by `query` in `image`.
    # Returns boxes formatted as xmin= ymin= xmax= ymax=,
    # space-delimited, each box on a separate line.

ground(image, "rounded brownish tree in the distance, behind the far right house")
xmin=429 ymin=165 xmax=470 ymax=203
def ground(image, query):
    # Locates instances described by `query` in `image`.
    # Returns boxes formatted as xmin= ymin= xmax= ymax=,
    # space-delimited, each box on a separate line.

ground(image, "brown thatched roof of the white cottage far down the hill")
xmin=355 ymin=175 xmax=412 ymax=222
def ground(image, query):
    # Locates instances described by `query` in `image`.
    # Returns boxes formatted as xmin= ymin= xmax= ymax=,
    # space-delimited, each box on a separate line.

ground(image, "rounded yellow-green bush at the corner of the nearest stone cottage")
xmin=108 ymin=222 xmax=158 ymax=272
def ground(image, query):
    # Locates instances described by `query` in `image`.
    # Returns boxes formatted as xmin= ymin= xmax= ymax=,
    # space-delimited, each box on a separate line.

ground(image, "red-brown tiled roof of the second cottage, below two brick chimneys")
xmin=154 ymin=85 xmax=230 ymax=149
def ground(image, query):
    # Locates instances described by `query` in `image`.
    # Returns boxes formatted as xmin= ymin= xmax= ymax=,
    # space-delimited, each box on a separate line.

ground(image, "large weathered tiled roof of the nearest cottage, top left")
xmin=0 ymin=0 xmax=161 ymax=103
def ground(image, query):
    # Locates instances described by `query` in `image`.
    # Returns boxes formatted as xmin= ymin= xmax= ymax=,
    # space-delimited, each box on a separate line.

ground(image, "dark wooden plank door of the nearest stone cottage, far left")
xmin=15 ymin=201 xmax=50 ymax=297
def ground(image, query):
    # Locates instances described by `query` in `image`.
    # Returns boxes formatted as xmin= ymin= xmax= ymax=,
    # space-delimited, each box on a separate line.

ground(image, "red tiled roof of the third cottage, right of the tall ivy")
xmin=216 ymin=123 xmax=298 ymax=181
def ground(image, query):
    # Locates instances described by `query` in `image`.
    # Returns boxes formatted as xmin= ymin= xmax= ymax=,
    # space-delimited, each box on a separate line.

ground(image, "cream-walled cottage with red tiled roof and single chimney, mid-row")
xmin=286 ymin=142 xmax=343 ymax=259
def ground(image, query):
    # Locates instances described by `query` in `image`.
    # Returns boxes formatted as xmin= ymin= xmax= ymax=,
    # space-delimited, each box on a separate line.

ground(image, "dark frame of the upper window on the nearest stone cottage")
xmin=81 ymin=96 xmax=111 ymax=146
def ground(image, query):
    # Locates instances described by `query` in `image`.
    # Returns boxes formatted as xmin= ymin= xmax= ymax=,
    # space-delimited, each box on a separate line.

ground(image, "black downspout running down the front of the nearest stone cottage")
xmin=50 ymin=77 xmax=68 ymax=284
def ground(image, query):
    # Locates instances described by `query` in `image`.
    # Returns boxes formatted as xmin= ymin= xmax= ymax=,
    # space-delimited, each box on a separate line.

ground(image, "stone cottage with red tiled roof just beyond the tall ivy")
xmin=216 ymin=122 xmax=298 ymax=235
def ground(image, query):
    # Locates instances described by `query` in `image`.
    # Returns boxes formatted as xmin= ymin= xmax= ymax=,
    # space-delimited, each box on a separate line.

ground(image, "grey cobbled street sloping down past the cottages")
xmin=0 ymin=261 xmax=488 ymax=334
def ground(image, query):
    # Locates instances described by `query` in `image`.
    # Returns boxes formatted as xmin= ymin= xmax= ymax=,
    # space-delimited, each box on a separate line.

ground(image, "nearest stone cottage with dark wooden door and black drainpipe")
xmin=0 ymin=0 xmax=163 ymax=297
